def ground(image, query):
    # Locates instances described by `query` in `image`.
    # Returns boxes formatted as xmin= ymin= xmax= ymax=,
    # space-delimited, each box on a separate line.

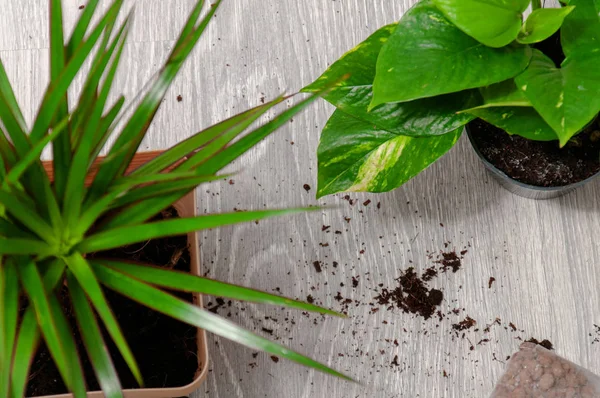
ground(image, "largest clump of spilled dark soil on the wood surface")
xmin=375 ymin=267 xmax=444 ymax=319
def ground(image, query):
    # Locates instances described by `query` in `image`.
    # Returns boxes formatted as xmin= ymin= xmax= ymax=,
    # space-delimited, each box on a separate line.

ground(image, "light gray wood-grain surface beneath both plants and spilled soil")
xmin=0 ymin=0 xmax=600 ymax=398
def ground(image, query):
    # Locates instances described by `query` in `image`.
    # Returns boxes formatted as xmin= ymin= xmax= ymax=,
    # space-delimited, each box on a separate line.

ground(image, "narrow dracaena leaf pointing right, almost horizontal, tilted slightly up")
xmin=77 ymin=208 xmax=310 ymax=253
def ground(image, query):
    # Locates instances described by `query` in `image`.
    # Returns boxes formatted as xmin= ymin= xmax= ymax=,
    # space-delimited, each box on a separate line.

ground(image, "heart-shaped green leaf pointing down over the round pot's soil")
xmin=515 ymin=50 xmax=600 ymax=146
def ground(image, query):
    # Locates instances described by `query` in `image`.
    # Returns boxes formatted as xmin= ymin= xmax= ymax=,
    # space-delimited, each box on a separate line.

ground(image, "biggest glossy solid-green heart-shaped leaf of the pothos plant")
xmin=370 ymin=0 xmax=531 ymax=108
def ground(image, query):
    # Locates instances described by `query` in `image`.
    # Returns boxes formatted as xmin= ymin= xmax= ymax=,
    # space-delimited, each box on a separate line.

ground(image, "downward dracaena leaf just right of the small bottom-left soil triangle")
xmin=17 ymin=260 xmax=74 ymax=390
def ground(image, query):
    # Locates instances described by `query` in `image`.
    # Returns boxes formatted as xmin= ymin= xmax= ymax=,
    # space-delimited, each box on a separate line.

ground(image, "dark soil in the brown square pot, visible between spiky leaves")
xmin=27 ymin=208 xmax=198 ymax=396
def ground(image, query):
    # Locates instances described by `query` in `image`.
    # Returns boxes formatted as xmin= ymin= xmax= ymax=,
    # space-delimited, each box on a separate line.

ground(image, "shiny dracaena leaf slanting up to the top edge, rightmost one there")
xmin=90 ymin=0 xmax=221 ymax=198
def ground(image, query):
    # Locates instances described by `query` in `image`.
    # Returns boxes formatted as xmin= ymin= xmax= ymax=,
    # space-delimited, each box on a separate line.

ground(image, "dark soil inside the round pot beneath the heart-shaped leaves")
xmin=469 ymin=119 xmax=600 ymax=187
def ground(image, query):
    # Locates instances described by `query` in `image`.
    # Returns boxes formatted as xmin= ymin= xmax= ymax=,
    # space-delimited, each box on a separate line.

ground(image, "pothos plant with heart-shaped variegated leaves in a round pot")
xmin=304 ymin=0 xmax=600 ymax=198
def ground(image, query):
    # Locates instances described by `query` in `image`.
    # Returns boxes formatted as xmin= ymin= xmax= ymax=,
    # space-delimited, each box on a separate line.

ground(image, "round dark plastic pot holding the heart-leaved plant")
xmin=465 ymin=124 xmax=600 ymax=200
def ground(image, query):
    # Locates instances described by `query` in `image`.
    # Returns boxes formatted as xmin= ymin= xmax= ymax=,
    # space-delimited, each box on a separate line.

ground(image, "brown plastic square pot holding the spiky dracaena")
xmin=43 ymin=151 xmax=208 ymax=398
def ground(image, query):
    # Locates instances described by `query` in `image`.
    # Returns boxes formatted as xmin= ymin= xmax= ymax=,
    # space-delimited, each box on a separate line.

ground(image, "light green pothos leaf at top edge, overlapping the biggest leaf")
xmin=434 ymin=0 xmax=530 ymax=47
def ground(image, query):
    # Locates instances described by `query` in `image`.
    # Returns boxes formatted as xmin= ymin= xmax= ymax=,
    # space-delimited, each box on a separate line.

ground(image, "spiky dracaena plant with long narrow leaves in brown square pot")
xmin=0 ymin=0 xmax=344 ymax=398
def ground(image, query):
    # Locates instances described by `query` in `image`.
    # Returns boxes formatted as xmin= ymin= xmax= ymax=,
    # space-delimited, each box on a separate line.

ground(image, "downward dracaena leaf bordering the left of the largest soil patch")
xmin=65 ymin=253 xmax=143 ymax=385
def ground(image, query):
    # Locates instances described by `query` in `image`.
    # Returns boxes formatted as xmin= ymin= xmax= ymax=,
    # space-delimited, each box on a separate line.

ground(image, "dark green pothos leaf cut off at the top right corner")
xmin=560 ymin=0 xmax=600 ymax=57
